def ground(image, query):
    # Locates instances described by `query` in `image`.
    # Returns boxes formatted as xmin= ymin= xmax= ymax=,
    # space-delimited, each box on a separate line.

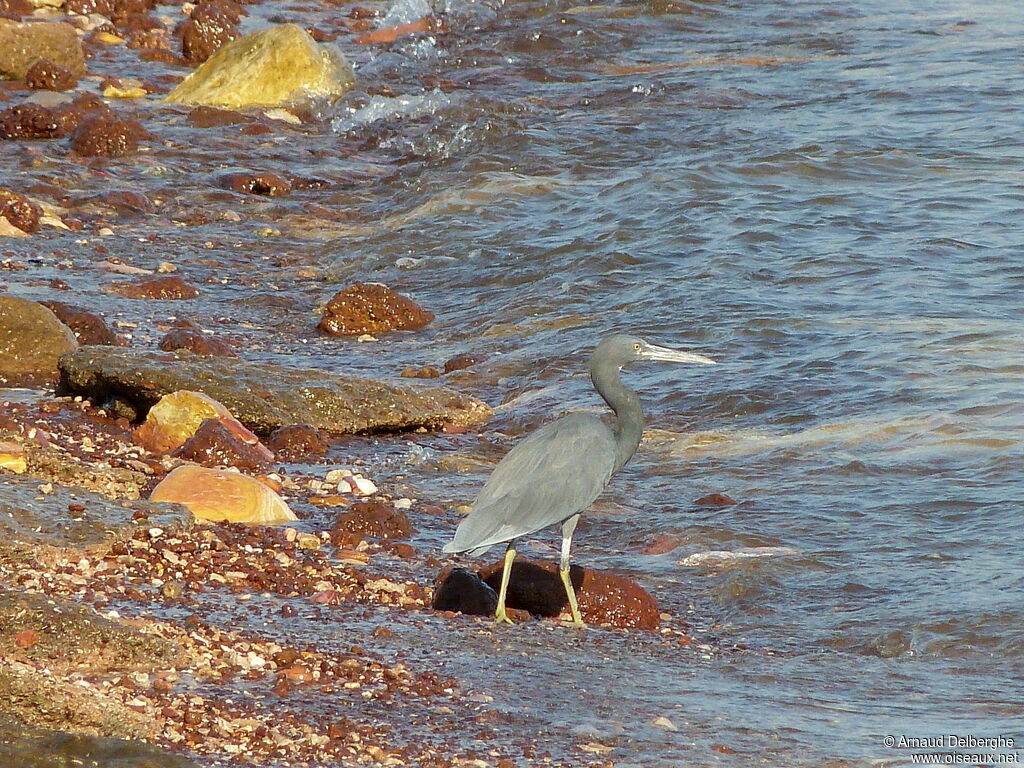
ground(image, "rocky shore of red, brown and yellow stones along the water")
xmin=0 ymin=0 xmax=704 ymax=768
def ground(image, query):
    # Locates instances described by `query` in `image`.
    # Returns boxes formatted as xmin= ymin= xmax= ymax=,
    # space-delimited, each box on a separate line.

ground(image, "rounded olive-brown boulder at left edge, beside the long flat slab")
xmin=0 ymin=296 xmax=78 ymax=387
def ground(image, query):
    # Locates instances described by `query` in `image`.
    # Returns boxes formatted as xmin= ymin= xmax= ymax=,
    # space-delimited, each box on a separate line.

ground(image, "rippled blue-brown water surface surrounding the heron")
xmin=8 ymin=0 xmax=1024 ymax=766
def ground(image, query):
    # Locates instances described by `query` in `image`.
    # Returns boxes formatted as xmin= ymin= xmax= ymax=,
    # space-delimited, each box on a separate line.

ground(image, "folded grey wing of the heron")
xmin=444 ymin=414 xmax=615 ymax=552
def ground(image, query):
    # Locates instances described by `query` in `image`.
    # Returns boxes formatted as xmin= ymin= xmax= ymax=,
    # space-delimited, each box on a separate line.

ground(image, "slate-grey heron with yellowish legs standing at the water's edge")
xmin=444 ymin=334 xmax=715 ymax=627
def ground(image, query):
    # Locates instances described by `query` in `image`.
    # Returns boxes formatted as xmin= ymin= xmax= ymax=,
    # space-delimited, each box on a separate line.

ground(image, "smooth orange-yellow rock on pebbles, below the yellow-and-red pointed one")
xmin=150 ymin=465 xmax=298 ymax=525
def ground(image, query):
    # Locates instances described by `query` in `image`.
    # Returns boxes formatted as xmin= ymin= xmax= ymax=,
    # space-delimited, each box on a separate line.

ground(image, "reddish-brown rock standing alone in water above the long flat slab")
xmin=319 ymin=283 xmax=434 ymax=336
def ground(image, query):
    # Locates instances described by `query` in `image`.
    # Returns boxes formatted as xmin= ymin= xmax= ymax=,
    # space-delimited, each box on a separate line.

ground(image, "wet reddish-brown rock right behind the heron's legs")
xmin=480 ymin=558 xmax=659 ymax=630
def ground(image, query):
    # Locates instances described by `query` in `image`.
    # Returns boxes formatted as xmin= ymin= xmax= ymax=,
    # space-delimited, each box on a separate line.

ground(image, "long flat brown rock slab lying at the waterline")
xmin=59 ymin=346 xmax=490 ymax=434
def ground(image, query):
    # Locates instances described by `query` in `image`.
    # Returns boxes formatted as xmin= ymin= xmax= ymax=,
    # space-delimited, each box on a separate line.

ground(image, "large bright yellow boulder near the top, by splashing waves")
xmin=165 ymin=24 xmax=355 ymax=109
